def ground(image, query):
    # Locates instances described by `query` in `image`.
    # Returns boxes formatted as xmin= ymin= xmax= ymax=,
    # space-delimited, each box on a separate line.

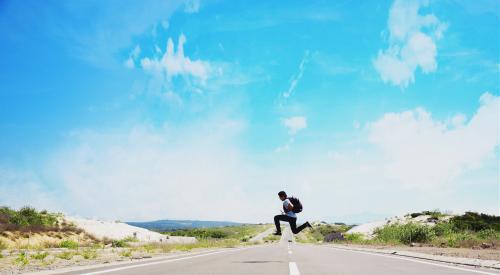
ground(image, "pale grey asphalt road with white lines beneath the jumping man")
xmin=56 ymin=229 xmax=500 ymax=275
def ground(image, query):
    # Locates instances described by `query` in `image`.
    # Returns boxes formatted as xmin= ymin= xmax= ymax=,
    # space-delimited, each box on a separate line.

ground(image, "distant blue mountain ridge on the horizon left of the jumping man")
xmin=126 ymin=220 xmax=241 ymax=231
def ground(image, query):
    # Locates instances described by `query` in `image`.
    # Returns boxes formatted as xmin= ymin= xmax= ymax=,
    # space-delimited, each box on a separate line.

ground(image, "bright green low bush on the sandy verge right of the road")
xmin=375 ymin=223 xmax=435 ymax=244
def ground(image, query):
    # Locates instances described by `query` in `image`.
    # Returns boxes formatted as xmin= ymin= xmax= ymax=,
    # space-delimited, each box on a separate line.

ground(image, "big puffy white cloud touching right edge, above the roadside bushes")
xmin=368 ymin=93 xmax=500 ymax=188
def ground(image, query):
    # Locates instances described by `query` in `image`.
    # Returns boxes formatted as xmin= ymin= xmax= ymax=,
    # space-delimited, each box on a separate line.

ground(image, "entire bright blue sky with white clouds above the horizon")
xmin=0 ymin=0 xmax=500 ymax=222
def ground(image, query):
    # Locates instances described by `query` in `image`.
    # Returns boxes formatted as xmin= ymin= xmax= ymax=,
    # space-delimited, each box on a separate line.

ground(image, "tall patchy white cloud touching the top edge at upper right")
xmin=373 ymin=0 xmax=446 ymax=88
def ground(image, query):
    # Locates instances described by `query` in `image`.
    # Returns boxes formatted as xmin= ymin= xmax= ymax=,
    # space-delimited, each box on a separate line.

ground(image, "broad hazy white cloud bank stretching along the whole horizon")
xmin=0 ymin=93 xmax=500 ymax=222
